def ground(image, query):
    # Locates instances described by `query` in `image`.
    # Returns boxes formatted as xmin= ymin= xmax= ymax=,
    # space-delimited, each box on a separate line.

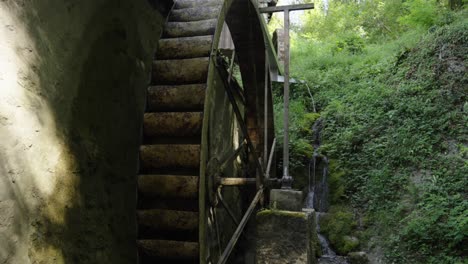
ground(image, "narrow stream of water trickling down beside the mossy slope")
xmin=305 ymin=119 xmax=348 ymax=264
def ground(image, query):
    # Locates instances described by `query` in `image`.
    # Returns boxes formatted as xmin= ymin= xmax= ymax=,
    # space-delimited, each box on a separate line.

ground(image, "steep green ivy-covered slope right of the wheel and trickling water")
xmin=293 ymin=8 xmax=468 ymax=263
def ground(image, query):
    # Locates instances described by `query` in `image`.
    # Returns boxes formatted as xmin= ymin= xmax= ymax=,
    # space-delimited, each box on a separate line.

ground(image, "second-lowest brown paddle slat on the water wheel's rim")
xmin=137 ymin=209 xmax=198 ymax=232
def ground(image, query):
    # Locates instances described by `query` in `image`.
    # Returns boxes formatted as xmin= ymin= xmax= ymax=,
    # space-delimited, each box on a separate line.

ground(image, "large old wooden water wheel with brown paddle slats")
xmin=137 ymin=0 xmax=273 ymax=263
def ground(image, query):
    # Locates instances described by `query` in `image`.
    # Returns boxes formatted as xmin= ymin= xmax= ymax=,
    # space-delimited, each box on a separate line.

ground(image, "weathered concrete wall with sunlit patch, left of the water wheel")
xmin=0 ymin=0 xmax=167 ymax=264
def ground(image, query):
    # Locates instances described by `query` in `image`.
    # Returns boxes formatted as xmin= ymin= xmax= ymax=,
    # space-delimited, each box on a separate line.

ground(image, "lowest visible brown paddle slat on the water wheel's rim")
xmin=137 ymin=239 xmax=199 ymax=260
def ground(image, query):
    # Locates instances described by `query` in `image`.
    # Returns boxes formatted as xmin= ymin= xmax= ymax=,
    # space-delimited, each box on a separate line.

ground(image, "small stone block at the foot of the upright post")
xmin=270 ymin=189 xmax=303 ymax=212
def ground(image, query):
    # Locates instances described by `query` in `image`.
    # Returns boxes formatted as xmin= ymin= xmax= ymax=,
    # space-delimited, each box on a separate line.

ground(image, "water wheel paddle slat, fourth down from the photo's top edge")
xmin=156 ymin=36 xmax=213 ymax=60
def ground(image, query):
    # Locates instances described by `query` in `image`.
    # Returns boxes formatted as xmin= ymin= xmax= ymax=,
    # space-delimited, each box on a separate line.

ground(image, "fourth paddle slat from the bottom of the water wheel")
xmin=140 ymin=144 xmax=200 ymax=171
